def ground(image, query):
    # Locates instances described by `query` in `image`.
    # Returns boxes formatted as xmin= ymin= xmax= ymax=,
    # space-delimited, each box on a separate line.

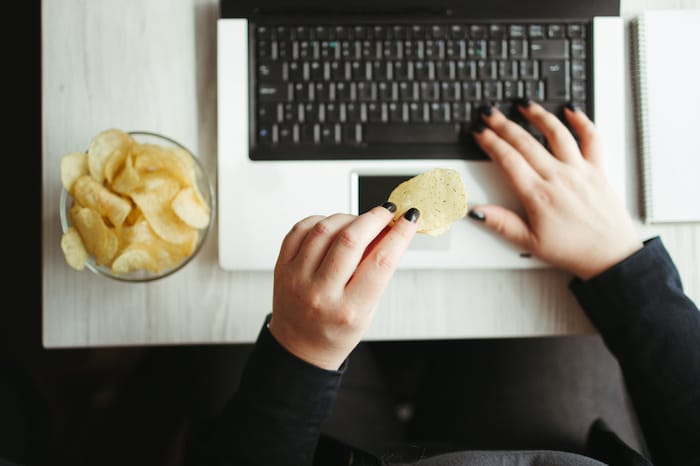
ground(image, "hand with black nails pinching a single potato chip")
xmin=269 ymin=203 xmax=420 ymax=370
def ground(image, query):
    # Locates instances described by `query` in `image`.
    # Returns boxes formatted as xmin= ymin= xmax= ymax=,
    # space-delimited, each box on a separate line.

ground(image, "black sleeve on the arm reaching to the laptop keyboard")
xmin=571 ymin=237 xmax=700 ymax=465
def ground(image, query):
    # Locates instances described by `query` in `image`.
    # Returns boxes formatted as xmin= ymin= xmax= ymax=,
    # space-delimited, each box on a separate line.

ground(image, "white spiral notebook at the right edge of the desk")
xmin=631 ymin=10 xmax=700 ymax=223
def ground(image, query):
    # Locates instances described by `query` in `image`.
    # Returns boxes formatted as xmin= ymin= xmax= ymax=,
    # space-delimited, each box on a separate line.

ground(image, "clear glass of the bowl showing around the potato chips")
xmin=59 ymin=131 xmax=216 ymax=283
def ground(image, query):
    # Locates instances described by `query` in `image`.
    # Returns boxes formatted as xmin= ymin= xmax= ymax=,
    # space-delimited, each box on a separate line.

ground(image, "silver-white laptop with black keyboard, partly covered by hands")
xmin=217 ymin=0 xmax=627 ymax=271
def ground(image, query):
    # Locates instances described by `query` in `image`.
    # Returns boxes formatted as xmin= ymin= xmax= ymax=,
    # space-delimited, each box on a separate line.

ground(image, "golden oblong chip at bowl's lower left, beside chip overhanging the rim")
xmin=70 ymin=204 xmax=119 ymax=265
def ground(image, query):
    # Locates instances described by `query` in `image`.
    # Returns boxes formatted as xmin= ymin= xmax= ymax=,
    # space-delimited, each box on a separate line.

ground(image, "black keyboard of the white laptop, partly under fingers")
xmin=251 ymin=21 xmax=590 ymax=160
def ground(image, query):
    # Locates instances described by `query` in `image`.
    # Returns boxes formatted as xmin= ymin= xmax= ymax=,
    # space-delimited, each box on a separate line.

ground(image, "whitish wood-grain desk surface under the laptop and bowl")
xmin=42 ymin=0 xmax=700 ymax=348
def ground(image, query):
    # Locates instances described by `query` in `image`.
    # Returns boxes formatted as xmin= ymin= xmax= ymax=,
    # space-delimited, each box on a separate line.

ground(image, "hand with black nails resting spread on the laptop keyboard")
xmin=469 ymin=101 xmax=642 ymax=280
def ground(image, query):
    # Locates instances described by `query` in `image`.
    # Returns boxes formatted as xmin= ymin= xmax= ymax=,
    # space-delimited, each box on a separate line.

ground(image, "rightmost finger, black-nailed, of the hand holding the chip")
xmin=346 ymin=209 xmax=420 ymax=303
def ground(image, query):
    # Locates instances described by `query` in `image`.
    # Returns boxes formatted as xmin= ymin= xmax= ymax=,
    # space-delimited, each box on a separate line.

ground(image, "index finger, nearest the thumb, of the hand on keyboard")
xmin=474 ymin=128 xmax=542 ymax=195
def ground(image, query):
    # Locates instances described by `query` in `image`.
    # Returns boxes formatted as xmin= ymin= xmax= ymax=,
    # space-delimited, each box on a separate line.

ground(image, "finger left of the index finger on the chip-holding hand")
xmin=318 ymin=206 xmax=396 ymax=287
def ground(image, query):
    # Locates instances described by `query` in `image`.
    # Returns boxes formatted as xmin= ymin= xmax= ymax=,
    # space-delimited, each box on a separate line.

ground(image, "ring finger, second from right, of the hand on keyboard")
xmin=518 ymin=102 xmax=581 ymax=163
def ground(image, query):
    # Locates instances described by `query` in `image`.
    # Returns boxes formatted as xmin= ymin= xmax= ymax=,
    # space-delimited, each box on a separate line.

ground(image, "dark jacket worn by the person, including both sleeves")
xmin=199 ymin=237 xmax=700 ymax=466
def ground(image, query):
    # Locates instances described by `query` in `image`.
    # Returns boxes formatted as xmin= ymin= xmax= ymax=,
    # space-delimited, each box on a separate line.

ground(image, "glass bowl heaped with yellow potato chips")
xmin=60 ymin=128 xmax=215 ymax=282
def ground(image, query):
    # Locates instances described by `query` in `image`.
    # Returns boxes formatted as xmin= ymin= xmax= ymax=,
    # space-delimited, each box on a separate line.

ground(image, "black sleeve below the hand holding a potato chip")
xmin=199 ymin=315 xmax=346 ymax=466
